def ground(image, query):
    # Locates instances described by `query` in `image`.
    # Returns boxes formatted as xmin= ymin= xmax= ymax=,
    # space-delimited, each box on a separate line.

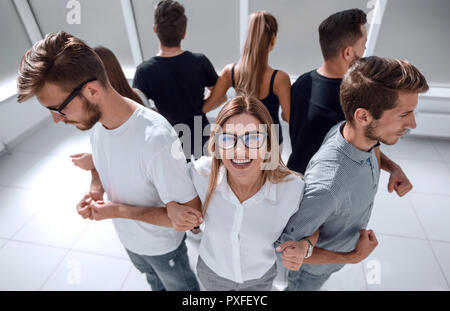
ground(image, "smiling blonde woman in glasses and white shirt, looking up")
xmin=190 ymin=96 xmax=316 ymax=290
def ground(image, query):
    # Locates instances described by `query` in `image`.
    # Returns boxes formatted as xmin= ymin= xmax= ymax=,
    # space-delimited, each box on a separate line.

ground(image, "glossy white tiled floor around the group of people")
xmin=0 ymin=120 xmax=450 ymax=290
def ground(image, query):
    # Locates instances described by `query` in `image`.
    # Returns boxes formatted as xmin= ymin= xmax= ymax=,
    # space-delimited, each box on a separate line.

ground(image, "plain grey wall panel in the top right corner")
xmin=375 ymin=0 xmax=450 ymax=87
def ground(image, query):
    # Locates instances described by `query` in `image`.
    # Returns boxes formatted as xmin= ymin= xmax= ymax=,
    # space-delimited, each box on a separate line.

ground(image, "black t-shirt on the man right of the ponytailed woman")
xmin=287 ymin=70 xmax=345 ymax=174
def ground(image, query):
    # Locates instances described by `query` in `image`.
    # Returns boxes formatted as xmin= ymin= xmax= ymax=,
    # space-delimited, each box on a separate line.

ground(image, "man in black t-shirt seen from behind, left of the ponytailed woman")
xmin=133 ymin=0 xmax=224 ymax=160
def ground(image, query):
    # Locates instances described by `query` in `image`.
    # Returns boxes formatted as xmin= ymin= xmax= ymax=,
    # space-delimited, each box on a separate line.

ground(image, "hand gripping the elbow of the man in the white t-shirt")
xmin=166 ymin=202 xmax=203 ymax=232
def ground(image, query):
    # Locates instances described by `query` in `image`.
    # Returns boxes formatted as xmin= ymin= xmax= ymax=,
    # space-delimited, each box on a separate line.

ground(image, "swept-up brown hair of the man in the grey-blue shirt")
xmin=340 ymin=56 xmax=428 ymax=123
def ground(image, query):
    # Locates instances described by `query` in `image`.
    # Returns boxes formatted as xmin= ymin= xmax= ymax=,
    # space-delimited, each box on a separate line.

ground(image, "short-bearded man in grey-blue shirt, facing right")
xmin=278 ymin=56 xmax=428 ymax=290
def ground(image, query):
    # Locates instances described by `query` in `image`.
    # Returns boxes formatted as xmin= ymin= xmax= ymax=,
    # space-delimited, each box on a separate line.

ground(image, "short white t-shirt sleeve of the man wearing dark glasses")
xmin=147 ymin=139 xmax=197 ymax=204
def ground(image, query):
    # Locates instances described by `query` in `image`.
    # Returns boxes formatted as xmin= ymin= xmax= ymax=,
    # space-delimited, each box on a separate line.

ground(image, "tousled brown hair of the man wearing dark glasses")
xmin=17 ymin=31 xmax=108 ymax=102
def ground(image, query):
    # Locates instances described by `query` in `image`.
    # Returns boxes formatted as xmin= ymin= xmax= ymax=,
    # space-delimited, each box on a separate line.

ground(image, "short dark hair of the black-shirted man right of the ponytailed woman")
xmin=319 ymin=9 xmax=367 ymax=60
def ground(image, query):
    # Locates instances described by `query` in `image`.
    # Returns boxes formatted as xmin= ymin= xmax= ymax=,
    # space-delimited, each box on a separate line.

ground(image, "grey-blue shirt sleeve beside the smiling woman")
xmin=275 ymin=187 xmax=337 ymax=246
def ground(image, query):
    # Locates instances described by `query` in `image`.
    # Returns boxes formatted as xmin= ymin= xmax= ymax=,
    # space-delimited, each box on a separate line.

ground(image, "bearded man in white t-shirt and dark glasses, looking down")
xmin=17 ymin=32 xmax=202 ymax=290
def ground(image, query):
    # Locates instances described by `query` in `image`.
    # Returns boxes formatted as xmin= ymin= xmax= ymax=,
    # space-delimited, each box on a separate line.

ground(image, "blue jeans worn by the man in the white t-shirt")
xmin=126 ymin=240 xmax=200 ymax=291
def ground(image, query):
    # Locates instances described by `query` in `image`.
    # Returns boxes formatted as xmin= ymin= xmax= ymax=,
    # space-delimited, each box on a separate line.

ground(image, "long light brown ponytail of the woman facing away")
xmin=235 ymin=11 xmax=278 ymax=97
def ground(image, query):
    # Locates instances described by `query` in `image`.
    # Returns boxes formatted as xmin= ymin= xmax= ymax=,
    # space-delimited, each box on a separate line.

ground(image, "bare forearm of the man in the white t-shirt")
xmin=117 ymin=203 xmax=172 ymax=227
